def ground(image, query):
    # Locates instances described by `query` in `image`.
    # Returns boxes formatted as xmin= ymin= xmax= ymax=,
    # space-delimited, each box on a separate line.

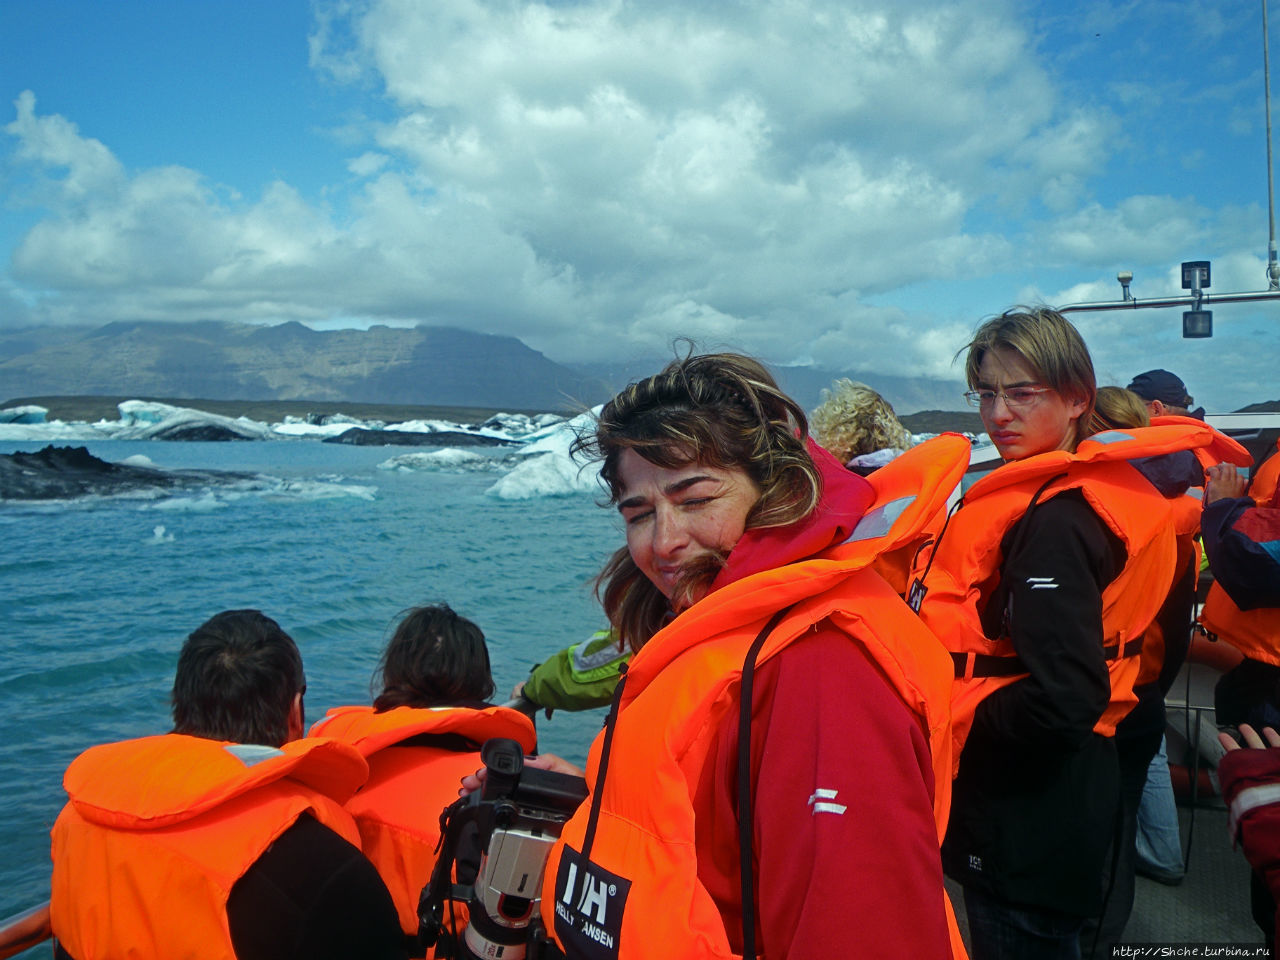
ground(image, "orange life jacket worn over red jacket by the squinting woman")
xmin=541 ymin=435 xmax=969 ymax=960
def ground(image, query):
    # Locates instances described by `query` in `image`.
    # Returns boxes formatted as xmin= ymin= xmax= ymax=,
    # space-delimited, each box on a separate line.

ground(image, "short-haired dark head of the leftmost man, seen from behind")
xmin=173 ymin=611 xmax=306 ymax=746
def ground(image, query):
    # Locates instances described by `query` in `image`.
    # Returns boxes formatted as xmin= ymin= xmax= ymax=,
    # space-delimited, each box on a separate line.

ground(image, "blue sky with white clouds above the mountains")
xmin=0 ymin=0 xmax=1280 ymax=411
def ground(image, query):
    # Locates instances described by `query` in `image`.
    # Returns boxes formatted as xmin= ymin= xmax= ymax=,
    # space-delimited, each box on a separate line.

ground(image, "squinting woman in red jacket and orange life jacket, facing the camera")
xmin=514 ymin=355 xmax=968 ymax=960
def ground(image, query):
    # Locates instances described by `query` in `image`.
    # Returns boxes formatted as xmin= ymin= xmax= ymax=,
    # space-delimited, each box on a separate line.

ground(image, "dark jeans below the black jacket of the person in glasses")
xmin=964 ymin=887 xmax=1084 ymax=960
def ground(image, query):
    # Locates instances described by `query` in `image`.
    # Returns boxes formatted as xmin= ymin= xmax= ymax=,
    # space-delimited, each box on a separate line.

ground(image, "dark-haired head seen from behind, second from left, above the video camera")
xmin=374 ymin=603 xmax=494 ymax=713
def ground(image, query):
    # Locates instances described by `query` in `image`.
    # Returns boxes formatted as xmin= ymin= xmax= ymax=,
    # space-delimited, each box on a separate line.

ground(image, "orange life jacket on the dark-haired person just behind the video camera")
xmin=311 ymin=707 xmax=538 ymax=936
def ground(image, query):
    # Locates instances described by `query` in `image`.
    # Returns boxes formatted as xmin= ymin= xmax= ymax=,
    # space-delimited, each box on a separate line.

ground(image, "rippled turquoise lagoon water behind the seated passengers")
xmin=0 ymin=440 xmax=621 ymax=931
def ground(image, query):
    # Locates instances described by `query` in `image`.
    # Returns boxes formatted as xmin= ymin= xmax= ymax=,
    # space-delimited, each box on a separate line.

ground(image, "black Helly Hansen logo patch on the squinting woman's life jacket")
xmin=556 ymin=846 xmax=631 ymax=960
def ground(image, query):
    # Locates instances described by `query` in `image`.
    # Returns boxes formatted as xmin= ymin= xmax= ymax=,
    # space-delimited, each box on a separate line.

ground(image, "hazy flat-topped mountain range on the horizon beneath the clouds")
xmin=0 ymin=320 xmax=964 ymax=413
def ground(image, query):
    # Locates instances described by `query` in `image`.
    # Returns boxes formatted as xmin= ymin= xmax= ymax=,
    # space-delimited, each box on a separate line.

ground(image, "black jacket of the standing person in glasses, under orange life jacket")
xmin=942 ymin=490 xmax=1125 ymax=916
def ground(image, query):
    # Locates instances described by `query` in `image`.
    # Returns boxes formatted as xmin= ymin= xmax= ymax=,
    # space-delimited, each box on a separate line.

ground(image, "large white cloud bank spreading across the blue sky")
xmin=5 ymin=0 xmax=1280 ymax=414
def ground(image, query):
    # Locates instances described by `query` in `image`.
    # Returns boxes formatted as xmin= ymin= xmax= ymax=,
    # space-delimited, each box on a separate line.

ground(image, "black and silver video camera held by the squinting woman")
xmin=417 ymin=737 xmax=586 ymax=960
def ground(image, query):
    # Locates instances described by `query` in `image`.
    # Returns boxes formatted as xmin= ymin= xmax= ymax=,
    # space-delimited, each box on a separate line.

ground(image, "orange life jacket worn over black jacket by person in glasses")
xmin=916 ymin=419 xmax=1248 ymax=760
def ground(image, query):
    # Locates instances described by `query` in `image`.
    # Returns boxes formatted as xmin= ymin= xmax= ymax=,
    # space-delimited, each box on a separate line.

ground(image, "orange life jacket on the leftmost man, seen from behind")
xmin=50 ymin=733 xmax=369 ymax=960
